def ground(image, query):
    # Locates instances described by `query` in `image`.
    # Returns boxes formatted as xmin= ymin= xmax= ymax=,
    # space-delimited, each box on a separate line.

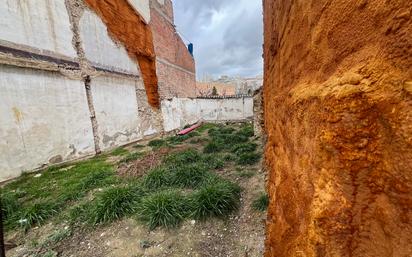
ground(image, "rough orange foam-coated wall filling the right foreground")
xmin=264 ymin=0 xmax=412 ymax=257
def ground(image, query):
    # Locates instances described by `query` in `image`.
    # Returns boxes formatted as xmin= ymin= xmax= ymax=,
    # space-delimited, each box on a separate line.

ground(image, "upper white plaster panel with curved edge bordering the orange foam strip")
xmin=79 ymin=11 xmax=140 ymax=75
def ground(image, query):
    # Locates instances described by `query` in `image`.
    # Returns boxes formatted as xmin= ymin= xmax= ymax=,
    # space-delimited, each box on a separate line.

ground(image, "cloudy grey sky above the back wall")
xmin=173 ymin=0 xmax=263 ymax=79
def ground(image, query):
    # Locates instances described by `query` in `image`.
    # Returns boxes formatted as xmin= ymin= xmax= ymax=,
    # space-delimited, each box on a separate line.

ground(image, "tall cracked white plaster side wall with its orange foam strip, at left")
xmin=0 ymin=0 xmax=163 ymax=181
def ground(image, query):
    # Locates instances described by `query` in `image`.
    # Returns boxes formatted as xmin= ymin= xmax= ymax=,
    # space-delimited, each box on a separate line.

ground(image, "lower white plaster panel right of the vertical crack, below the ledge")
xmin=91 ymin=76 xmax=143 ymax=150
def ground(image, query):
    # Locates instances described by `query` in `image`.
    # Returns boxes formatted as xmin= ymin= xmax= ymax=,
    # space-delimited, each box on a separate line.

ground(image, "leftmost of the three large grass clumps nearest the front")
xmin=87 ymin=186 xmax=144 ymax=224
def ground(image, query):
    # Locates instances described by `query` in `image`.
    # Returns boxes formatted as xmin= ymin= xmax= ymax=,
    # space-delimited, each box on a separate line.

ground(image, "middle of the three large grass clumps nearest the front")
xmin=138 ymin=190 xmax=188 ymax=229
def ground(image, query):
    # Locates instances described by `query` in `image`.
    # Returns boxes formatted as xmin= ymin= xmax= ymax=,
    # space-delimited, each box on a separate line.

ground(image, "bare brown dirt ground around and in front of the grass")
xmin=7 ymin=122 xmax=266 ymax=257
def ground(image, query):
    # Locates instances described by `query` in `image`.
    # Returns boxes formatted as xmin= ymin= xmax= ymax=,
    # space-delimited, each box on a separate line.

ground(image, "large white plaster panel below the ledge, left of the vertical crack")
xmin=0 ymin=67 xmax=94 ymax=181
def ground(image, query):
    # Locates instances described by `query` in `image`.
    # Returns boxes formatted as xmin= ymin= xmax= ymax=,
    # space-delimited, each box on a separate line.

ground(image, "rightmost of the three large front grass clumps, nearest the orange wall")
xmin=191 ymin=181 xmax=240 ymax=219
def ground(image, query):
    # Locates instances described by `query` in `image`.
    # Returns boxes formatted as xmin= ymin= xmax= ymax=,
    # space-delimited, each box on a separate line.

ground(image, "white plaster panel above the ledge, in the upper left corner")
xmin=0 ymin=0 xmax=76 ymax=57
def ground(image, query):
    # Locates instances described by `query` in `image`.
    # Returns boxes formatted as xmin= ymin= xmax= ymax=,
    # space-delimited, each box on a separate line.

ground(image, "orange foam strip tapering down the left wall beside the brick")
xmin=85 ymin=0 xmax=160 ymax=107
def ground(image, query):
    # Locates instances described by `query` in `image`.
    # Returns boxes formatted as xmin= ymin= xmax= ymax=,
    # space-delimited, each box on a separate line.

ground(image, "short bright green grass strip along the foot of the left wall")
xmin=1 ymin=157 xmax=119 ymax=230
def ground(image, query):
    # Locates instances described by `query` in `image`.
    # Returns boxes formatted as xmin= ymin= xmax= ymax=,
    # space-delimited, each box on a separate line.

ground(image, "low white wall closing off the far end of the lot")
xmin=162 ymin=97 xmax=253 ymax=131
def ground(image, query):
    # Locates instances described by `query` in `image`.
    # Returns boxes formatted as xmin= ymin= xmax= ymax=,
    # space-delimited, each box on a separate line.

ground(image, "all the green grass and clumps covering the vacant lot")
xmin=1 ymin=124 xmax=260 ymax=232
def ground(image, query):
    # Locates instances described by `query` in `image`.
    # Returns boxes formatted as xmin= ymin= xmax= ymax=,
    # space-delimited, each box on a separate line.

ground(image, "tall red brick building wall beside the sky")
xmin=150 ymin=0 xmax=196 ymax=99
